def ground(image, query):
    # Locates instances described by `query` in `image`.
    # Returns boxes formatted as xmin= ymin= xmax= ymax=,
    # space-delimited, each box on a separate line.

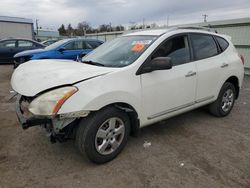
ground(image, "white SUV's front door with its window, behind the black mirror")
xmin=141 ymin=35 xmax=197 ymax=120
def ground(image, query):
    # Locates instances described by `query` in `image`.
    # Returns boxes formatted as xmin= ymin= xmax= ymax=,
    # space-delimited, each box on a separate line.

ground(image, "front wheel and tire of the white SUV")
xmin=75 ymin=107 xmax=130 ymax=164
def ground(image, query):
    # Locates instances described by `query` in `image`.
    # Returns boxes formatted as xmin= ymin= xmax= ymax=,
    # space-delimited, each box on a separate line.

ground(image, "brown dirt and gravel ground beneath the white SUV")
xmin=0 ymin=65 xmax=250 ymax=188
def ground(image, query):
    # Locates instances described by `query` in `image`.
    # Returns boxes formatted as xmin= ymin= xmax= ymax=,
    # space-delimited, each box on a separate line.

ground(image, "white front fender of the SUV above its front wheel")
xmin=58 ymin=72 xmax=141 ymax=119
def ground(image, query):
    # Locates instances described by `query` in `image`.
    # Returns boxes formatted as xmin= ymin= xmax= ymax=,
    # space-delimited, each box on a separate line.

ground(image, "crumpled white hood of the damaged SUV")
xmin=11 ymin=59 xmax=117 ymax=96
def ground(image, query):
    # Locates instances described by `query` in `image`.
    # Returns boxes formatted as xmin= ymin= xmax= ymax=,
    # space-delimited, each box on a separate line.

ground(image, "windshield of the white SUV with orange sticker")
xmin=82 ymin=36 xmax=156 ymax=67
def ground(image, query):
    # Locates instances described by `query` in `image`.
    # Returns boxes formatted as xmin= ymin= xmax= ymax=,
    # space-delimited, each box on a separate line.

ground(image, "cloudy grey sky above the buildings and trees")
xmin=0 ymin=0 xmax=250 ymax=29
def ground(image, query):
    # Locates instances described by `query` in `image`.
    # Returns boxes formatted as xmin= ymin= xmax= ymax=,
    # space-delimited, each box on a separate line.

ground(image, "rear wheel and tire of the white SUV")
xmin=209 ymin=82 xmax=236 ymax=117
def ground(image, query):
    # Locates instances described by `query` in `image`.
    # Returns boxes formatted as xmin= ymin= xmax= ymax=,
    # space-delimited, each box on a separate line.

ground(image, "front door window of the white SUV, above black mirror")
xmin=152 ymin=36 xmax=190 ymax=66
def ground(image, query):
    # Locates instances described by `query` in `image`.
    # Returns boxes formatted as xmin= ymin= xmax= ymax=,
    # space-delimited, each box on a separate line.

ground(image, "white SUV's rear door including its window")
xmin=190 ymin=33 xmax=225 ymax=103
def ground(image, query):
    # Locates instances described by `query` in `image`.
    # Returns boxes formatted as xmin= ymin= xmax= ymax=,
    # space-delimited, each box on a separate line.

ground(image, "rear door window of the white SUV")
xmin=190 ymin=34 xmax=218 ymax=60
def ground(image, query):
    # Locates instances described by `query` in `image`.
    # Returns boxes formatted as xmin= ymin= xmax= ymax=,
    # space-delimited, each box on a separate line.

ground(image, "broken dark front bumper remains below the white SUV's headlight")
xmin=16 ymin=95 xmax=52 ymax=129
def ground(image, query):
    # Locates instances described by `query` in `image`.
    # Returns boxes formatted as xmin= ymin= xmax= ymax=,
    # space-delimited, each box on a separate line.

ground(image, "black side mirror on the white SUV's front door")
xmin=140 ymin=57 xmax=172 ymax=74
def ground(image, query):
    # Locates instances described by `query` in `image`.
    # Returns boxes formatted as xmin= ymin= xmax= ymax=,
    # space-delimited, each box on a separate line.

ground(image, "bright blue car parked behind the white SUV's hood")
xmin=14 ymin=38 xmax=103 ymax=68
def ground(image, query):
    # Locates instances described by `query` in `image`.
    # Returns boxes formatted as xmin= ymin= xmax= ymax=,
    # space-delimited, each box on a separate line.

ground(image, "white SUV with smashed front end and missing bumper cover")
xmin=11 ymin=28 xmax=244 ymax=163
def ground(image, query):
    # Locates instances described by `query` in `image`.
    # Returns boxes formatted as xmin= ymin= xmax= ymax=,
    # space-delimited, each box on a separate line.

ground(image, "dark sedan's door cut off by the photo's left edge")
xmin=0 ymin=39 xmax=17 ymax=63
